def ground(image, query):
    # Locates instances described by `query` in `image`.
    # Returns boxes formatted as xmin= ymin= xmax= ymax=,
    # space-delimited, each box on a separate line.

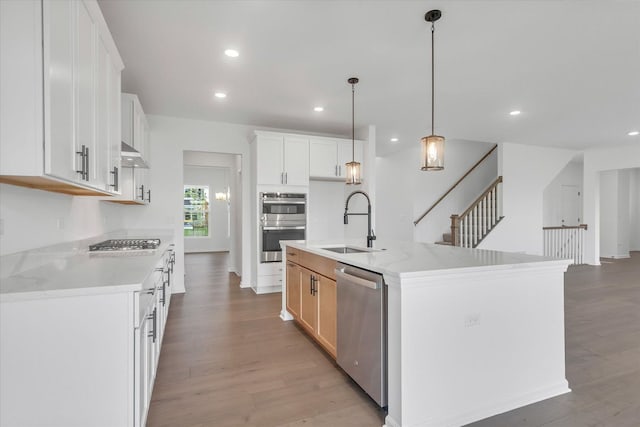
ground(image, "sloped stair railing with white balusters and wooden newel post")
xmin=451 ymin=176 xmax=503 ymax=248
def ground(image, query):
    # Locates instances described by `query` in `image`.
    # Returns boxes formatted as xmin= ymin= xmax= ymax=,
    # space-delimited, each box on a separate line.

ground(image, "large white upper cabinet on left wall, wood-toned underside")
xmin=0 ymin=0 xmax=123 ymax=195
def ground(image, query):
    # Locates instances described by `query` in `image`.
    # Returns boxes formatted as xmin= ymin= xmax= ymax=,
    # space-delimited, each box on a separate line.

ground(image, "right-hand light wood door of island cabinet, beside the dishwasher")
xmin=316 ymin=275 xmax=338 ymax=357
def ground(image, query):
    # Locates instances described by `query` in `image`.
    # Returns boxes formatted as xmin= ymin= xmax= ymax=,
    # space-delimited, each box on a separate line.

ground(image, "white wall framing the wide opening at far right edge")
xmin=583 ymin=144 xmax=640 ymax=265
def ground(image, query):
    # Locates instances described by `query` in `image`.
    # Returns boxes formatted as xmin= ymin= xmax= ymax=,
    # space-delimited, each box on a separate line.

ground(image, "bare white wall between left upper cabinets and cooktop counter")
xmin=0 ymin=184 xmax=134 ymax=255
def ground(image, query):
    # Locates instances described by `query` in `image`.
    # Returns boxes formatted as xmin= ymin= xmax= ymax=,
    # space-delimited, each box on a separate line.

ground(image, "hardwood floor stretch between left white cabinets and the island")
xmin=147 ymin=253 xmax=384 ymax=427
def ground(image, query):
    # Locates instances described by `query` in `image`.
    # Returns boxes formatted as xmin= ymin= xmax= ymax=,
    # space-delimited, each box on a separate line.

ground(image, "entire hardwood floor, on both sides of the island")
xmin=147 ymin=252 xmax=640 ymax=427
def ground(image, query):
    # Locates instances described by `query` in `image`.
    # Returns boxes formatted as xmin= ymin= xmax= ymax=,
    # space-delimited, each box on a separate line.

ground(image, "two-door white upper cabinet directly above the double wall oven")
xmin=255 ymin=132 xmax=309 ymax=186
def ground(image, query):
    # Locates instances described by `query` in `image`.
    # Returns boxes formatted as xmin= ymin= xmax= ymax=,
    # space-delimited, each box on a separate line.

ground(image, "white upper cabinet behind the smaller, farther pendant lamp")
xmin=309 ymin=137 xmax=364 ymax=180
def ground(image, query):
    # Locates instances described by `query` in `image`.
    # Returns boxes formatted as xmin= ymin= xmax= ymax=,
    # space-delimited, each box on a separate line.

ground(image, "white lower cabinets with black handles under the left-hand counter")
xmin=0 ymin=249 xmax=175 ymax=427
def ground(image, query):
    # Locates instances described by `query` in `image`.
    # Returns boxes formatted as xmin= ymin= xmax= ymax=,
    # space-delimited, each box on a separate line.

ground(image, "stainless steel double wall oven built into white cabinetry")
xmin=260 ymin=193 xmax=307 ymax=262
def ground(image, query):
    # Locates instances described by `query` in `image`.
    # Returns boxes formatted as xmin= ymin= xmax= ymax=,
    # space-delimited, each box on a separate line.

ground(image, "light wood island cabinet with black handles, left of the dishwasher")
xmin=286 ymin=247 xmax=337 ymax=358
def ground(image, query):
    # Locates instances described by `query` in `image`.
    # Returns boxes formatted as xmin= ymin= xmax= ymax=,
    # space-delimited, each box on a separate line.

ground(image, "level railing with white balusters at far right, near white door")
xmin=542 ymin=224 xmax=587 ymax=264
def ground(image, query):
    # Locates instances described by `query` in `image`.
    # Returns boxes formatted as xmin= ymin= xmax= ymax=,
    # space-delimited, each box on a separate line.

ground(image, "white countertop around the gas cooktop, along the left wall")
xmin=0 ymin=230 xmax=173 ymax=302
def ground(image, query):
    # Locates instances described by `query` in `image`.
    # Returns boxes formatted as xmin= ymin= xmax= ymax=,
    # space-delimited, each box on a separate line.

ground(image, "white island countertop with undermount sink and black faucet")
xmin=281 ymin=240 xmax=570 ymax=279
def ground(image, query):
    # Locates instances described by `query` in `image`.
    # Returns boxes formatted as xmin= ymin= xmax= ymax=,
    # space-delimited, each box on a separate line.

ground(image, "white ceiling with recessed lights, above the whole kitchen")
xmin=99 ymin=0 xmax=640 ymax=155
